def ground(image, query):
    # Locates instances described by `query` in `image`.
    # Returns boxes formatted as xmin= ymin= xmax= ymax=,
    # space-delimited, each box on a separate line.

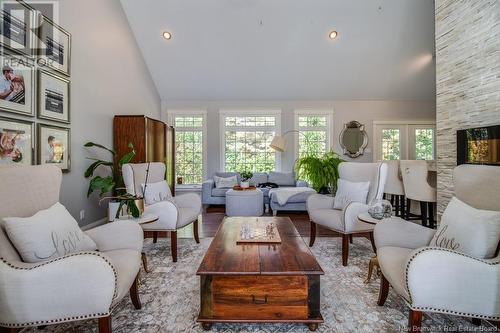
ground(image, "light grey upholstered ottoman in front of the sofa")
xmin=226 ymin=189 xmax=264 ymax=216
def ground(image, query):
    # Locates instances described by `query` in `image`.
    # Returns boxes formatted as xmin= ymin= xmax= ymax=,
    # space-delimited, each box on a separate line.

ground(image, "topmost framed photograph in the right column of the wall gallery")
xmin=38 ymin=15 xmax=71 ymax=76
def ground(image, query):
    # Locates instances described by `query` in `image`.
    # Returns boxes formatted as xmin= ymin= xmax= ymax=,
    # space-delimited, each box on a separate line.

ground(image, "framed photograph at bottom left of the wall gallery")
xmin=0 ymin=118 xmax=35 ymax=168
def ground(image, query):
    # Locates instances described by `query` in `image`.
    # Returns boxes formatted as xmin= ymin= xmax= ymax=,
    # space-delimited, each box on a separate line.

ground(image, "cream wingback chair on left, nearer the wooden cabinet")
xmin=122 ymin=162 xmax=201 ymax=262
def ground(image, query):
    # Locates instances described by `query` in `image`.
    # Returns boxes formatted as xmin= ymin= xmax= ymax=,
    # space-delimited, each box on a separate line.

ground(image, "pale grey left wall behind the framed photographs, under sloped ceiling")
xmin=0 ymin=0 xmax=161 ymax=225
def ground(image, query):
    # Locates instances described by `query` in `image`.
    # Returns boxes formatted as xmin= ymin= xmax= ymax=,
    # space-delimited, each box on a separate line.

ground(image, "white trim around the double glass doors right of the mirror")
xmin=372 ymin=119 xmax=437 ymax=162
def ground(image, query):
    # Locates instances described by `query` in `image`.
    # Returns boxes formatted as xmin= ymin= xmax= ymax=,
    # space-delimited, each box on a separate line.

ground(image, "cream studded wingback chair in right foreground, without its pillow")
xmin=374 ymin=165 xmax=500 ymax=332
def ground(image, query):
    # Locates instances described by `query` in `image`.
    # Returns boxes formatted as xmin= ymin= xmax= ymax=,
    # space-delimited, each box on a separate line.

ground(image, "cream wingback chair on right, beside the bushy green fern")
xmin=307 ymin=162 xmax=387 ymax=266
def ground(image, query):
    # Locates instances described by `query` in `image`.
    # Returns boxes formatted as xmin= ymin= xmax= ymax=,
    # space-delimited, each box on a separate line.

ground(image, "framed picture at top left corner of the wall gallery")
xmin=0 ymin=0 xmax=38 ymax=57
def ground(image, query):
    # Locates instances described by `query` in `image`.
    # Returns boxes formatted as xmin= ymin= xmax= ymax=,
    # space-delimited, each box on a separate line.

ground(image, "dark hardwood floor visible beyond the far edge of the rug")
xmin=145 ymin=206 xmax=340 ymax=238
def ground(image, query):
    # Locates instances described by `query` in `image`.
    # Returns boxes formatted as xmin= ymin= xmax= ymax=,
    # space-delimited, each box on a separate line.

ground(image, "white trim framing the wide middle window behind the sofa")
xmin=219 ymin=108 xmax=281 ymax=172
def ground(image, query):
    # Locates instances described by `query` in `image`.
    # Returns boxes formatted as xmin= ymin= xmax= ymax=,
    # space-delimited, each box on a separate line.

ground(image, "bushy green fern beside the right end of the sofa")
xmin=295 ymin=152 xmax=344 ymax=194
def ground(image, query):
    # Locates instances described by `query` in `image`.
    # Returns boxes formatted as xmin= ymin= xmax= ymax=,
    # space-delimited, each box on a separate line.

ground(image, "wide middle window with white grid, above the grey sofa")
xmin=221 ymin=112 xmax=280 ymax=172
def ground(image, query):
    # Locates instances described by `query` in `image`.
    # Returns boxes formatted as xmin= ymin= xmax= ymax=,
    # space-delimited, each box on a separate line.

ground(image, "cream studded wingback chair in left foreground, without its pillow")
xmin=0 ymin=166 xmax=143 ymax=333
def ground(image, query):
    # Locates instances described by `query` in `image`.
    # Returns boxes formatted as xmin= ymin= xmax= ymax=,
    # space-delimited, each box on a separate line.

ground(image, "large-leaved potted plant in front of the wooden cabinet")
xmin=83 ymin=142 xmax=143 ymax=221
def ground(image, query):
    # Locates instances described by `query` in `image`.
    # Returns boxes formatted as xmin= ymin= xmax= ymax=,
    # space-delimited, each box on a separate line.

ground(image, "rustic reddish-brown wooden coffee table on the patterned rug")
xmin=196 ymin=217 xmax=324 ymax=331
